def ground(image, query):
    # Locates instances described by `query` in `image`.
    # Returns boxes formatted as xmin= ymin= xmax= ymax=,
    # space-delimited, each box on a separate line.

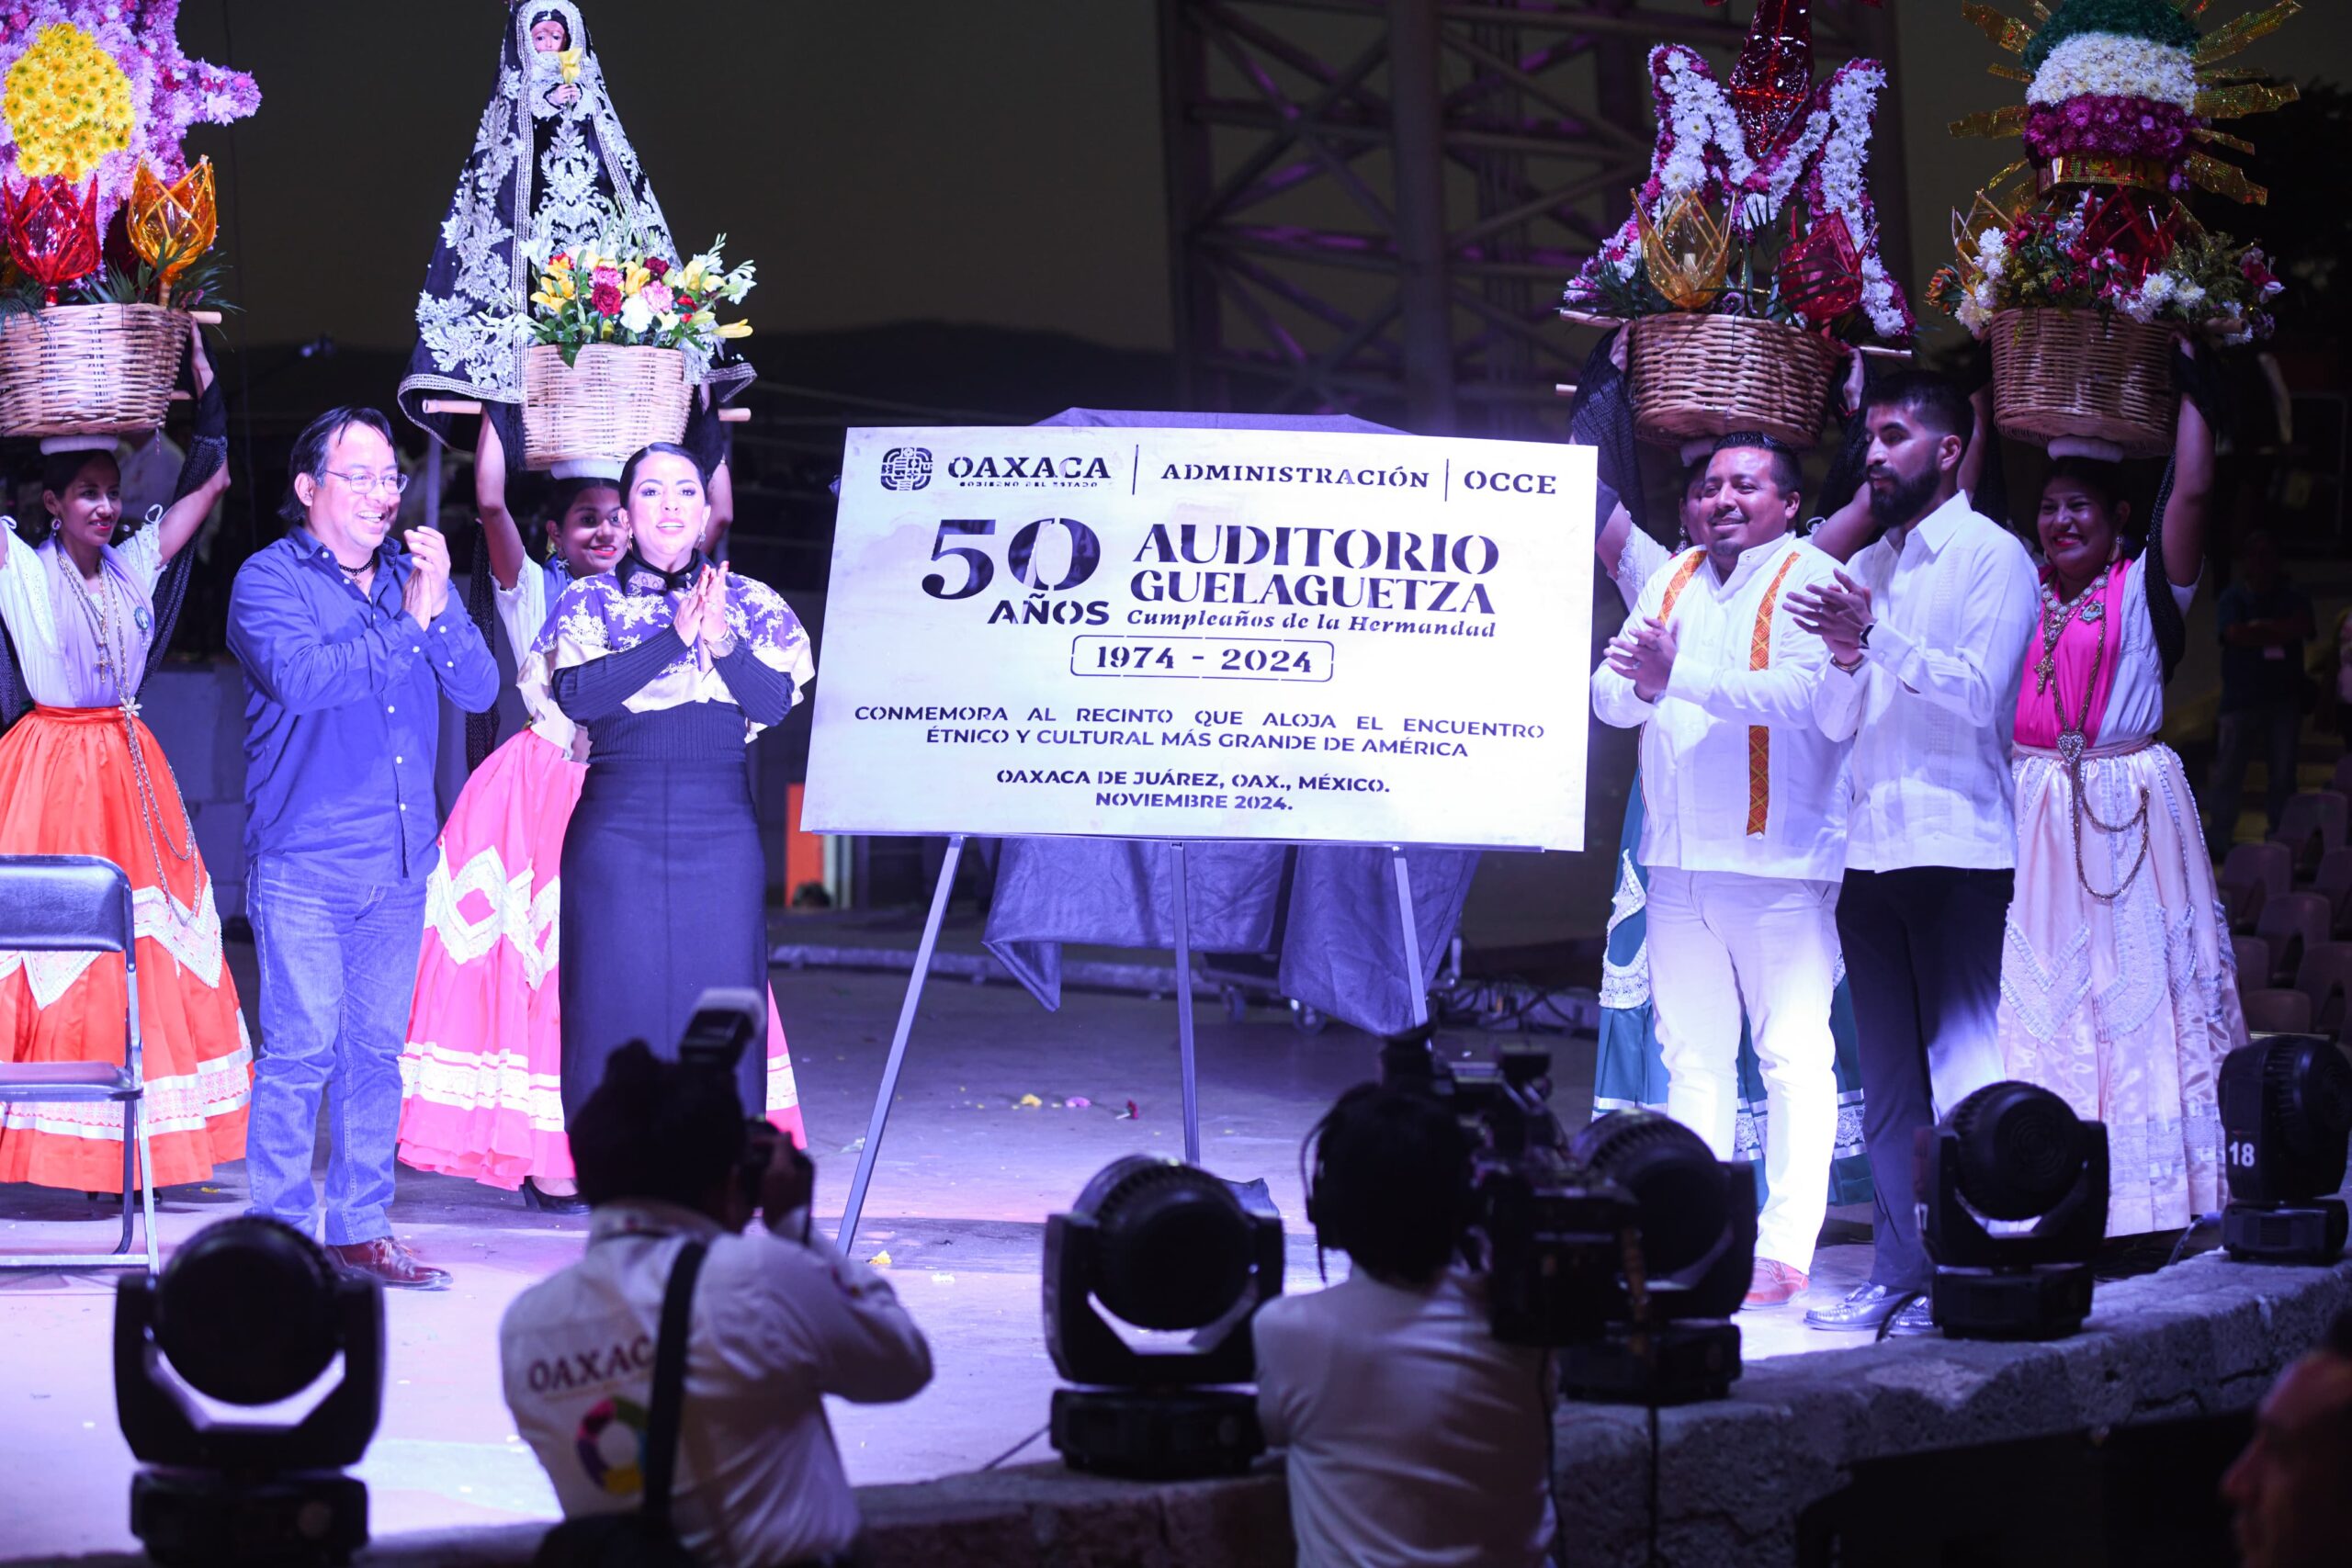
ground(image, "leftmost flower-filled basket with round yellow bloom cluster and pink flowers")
xmin=0 ymin=0 xmax=261 ymax=434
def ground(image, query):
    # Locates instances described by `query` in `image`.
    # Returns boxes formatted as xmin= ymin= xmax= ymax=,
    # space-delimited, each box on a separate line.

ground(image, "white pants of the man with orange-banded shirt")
xmin=1649 ymin=865 xmax=1837 ymax=1272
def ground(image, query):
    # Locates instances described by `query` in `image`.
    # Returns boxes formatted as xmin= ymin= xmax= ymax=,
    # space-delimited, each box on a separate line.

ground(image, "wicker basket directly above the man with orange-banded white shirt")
xmin=1628 ymin=310 xmax=1839 ymax=446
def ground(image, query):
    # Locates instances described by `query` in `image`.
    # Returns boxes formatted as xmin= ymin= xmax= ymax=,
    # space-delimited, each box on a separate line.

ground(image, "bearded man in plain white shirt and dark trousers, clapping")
xmin=1792 ymin=374 xmax=2041 ymax=1333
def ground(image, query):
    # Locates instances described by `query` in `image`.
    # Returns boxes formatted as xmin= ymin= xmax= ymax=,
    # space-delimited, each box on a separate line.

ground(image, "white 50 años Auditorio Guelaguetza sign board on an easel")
xmin=802 ymin=425 xmax=1595 ymax=849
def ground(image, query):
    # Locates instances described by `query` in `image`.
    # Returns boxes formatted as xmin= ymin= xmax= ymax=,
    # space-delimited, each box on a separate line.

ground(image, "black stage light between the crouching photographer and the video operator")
xmin=1045 ymin=1155 xmax=1282 ymax=1481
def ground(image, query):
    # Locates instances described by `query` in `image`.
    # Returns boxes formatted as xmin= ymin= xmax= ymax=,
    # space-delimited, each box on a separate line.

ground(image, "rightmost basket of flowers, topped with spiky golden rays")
xmin=1928 ymin=0 xmax=2301 ymax=456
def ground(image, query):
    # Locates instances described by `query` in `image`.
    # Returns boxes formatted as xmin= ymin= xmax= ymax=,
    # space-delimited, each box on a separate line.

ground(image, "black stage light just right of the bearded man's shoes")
xmin=1917 ymin=1084 xmax=2108 ymax=1340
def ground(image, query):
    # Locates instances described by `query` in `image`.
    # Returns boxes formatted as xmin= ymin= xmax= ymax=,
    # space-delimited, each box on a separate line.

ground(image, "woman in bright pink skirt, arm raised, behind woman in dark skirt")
xmin=400 ymin=419 xmax=802 ymax=1213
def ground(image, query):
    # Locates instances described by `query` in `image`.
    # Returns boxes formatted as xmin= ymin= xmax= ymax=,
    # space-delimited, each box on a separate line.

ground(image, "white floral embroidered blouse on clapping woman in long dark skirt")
xmin=515 ymin=555 xmax=816 ymax=743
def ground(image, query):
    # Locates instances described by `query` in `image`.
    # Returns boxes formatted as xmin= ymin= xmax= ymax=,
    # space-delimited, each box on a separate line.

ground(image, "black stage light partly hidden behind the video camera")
xmin=1559 ymin=1110 xmax=1757 ymax=1405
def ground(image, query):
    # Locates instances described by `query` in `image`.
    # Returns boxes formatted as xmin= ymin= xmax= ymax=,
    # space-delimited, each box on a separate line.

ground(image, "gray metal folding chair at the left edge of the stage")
xmin=0 ymin=856 xmax=163 ymax=1274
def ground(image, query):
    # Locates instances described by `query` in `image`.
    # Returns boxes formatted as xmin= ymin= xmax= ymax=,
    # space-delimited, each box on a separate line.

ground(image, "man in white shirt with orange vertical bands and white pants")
xmin=1592 ymin=434 xmax=1847 ymax=1307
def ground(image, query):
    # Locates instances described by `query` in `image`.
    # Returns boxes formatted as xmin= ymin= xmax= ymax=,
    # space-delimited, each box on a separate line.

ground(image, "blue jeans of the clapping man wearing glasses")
xmin=244 ymin=856 xmax=425 ymax=1246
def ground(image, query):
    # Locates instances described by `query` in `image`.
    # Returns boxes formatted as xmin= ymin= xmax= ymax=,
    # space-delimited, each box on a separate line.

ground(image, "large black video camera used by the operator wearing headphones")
xmin=1381 ymin=1030 xmax=1639 ymax=1347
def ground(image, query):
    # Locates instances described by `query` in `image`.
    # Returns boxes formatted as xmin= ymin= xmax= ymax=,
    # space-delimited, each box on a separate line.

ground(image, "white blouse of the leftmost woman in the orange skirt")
xmin=0 ymin=517 xmax=163 ymax=707
